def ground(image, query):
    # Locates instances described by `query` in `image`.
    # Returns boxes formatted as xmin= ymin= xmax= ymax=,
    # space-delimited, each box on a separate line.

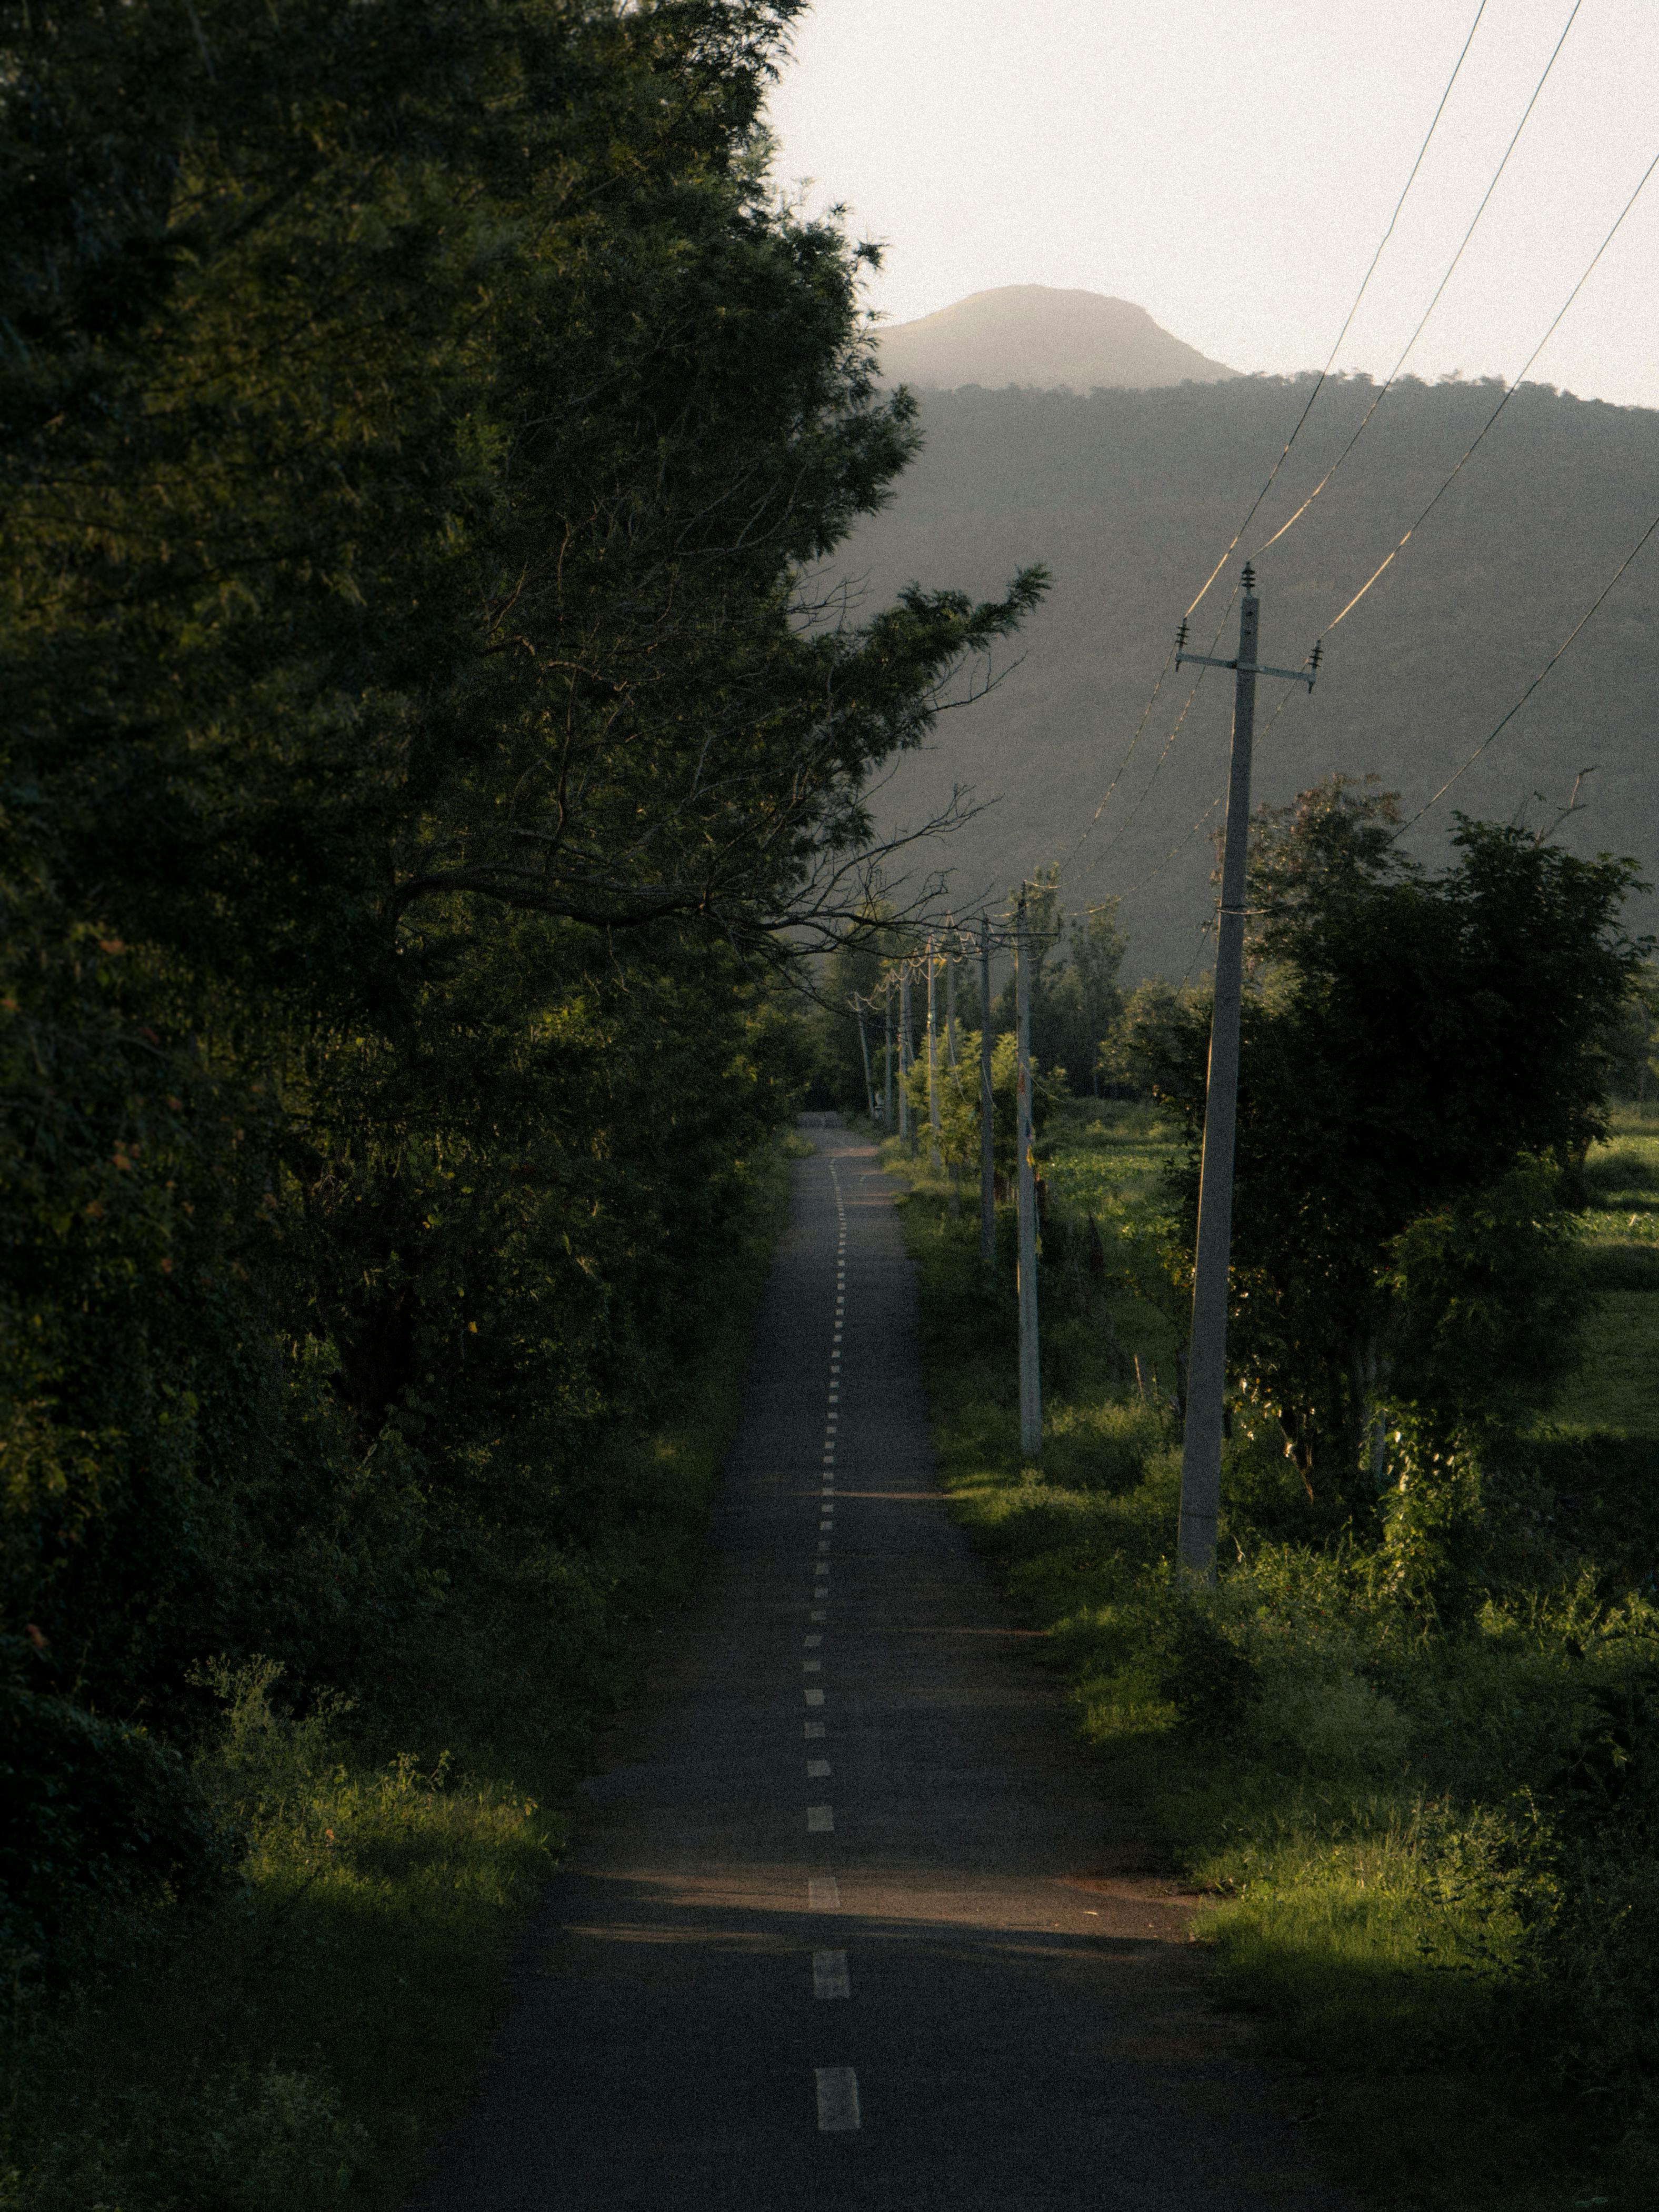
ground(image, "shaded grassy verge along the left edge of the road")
xmin=0 ymin=1148 xmax=787 ymax=2212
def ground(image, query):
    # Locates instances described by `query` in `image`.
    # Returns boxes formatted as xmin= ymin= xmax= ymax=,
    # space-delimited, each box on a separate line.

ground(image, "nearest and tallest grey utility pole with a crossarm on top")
xmin=1175 ymin=562 xmax=1321 ymax=1582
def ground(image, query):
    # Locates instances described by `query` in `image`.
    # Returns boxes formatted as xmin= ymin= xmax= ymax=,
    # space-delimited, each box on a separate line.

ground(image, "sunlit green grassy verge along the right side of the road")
xmin=894 ymin=1108 xmax=1659 ymax=2212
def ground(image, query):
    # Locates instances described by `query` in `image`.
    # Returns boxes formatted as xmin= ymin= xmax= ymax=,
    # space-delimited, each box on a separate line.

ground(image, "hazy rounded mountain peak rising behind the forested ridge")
xmin=881 ymin=283 xmax=1238 ymax=392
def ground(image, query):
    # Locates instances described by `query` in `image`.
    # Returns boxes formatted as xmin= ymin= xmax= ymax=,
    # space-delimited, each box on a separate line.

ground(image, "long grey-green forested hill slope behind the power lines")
xmin=841 ymin=376 xmax=1659 ymax=976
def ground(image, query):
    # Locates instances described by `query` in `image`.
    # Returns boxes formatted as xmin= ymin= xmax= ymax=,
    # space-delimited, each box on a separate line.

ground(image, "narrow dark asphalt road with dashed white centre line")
xmin=416 ymin=1126 xmax=1338 ymax=2212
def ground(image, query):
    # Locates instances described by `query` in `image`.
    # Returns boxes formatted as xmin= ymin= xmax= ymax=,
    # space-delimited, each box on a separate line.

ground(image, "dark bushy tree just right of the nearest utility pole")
xmin=1159 ymin=778 xmax=1646 ymax=1504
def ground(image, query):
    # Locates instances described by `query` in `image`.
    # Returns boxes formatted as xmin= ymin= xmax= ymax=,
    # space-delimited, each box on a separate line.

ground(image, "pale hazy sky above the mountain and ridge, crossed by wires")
xmin=772 ymin=0 xmax=1659 ymax=407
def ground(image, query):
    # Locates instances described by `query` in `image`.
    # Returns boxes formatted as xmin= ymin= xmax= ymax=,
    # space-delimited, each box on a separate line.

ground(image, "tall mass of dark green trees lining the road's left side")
xmin=0 ymin=0 xmax=1040 ymax=1953
